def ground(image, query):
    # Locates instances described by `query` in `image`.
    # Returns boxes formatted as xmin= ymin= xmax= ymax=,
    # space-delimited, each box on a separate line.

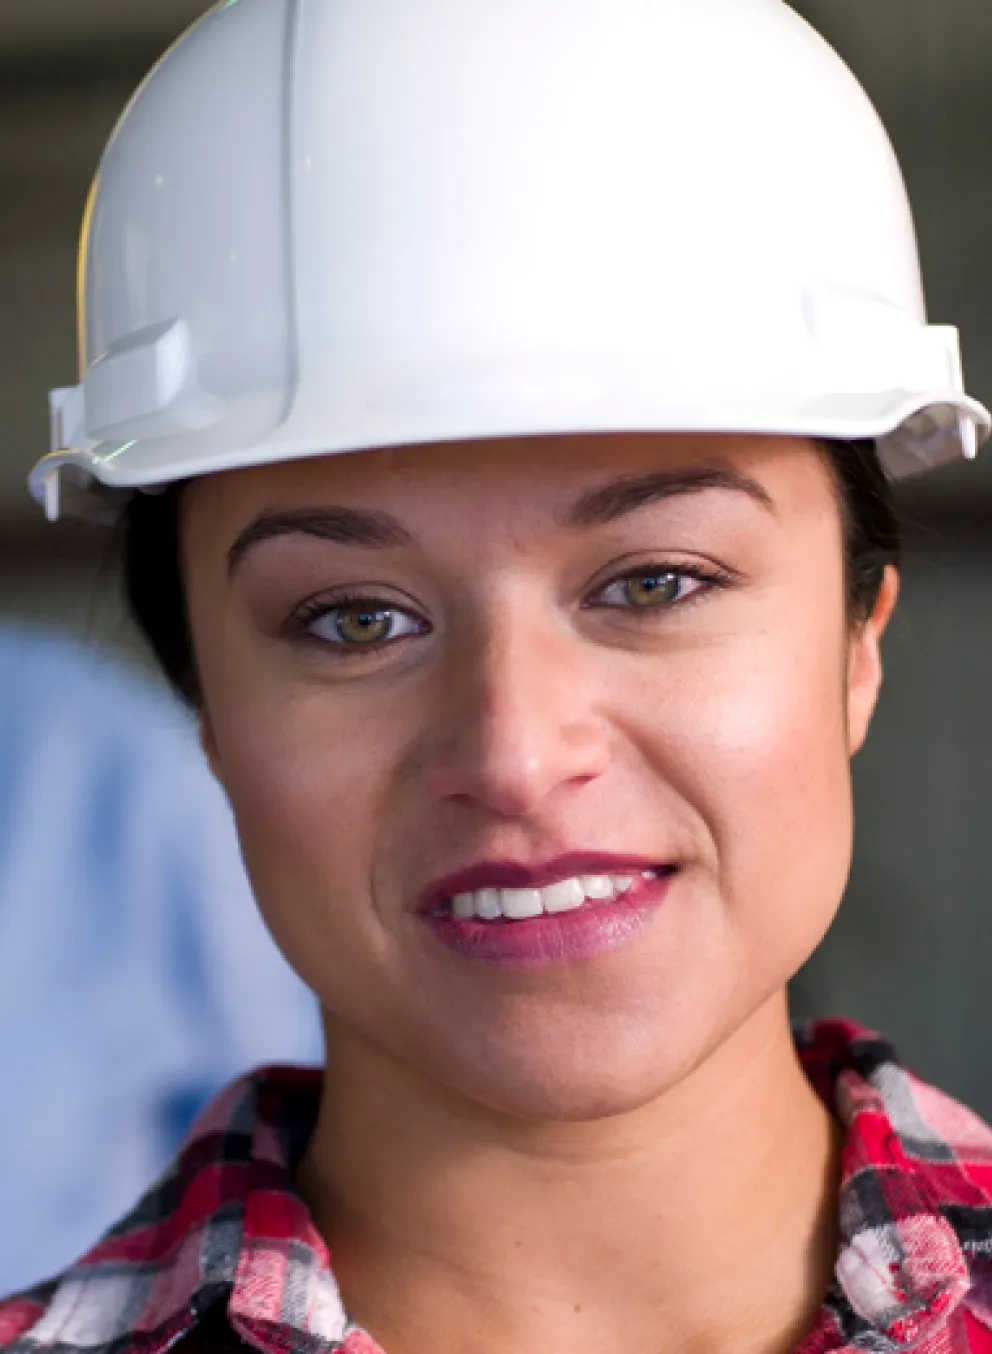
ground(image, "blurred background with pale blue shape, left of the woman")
xmin=0 ymin=0 xmax=321 ymax=1294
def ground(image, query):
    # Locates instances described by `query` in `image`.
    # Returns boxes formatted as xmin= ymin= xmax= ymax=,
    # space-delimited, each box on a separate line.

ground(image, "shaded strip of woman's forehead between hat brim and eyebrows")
xmin=188 ymin=433 xmax=831 ymax=529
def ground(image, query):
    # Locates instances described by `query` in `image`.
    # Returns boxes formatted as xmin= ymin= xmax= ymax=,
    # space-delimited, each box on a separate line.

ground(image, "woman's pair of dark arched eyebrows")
xmin=227 ymin=466 xmax=774 ymax=574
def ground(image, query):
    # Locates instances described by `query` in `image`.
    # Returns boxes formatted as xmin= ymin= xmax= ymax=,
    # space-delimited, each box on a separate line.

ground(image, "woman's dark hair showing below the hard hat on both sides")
xmin=122 ymin=441 xmax=903 ymax=707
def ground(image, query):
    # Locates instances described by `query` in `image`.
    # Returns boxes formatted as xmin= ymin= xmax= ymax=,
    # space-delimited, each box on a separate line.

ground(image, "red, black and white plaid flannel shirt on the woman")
xmin=0 ymin=1021 xmax=992 ymax=1354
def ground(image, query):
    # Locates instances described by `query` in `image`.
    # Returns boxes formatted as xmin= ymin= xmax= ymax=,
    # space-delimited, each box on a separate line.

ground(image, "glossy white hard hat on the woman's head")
xmin=31 ymin=0 xmax=989 ymax=516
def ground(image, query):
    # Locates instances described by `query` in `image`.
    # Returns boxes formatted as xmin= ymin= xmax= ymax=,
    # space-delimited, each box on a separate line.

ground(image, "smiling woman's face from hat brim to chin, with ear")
xmin=183 ymin=436 xmax=895 ymax=1120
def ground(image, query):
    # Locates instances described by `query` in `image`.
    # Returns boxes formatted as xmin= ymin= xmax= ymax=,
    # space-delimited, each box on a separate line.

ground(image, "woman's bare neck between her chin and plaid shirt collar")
xmin=300 ymin=995 xmax=839 ymax=1354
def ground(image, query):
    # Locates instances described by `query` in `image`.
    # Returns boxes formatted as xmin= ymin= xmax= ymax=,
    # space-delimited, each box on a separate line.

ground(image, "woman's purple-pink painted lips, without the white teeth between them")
xmin=417 ymin=852 xmax=678 ymax=968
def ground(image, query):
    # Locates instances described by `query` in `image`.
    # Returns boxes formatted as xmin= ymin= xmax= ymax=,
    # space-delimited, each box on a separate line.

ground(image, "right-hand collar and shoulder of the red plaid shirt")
xmin=797 ymin=1021 xmax=992 ymax=1354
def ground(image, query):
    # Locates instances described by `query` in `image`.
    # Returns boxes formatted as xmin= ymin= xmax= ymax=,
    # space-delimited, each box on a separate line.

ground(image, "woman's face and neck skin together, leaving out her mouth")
xmin=183 ymin=435 xmax=897 ymax=1354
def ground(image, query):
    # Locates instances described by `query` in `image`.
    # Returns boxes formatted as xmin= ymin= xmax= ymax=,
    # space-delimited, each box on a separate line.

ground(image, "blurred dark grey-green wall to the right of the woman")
xmin=794 ymin=0 xmax=992 ymax=1117
